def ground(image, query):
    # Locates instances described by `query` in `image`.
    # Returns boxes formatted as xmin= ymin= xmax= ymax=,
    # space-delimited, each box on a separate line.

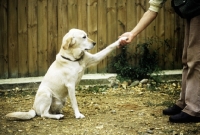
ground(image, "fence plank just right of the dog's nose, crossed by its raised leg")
xmin=97 ymin=0 xmax=107 ymax=73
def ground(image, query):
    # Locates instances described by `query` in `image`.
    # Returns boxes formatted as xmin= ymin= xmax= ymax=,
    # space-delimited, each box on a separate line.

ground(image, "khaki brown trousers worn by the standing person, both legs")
xmin=176 ymin=16 xmax=200 ymax=117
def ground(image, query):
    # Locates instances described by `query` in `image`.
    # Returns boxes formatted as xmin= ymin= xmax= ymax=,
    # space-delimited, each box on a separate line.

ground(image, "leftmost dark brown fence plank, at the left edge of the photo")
xmin=0 ymin=0 xmax=8 ymax=78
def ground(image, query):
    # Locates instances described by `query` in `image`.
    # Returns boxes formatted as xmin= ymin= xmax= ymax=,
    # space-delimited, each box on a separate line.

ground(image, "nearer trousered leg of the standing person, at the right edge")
xmin=183 ymin=16 xmax=200 ymax=117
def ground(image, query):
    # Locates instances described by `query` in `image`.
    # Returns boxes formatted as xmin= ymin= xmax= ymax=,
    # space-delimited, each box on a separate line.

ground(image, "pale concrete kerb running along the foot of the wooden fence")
xmin=0 ymin=70 xmax=182 ymax=90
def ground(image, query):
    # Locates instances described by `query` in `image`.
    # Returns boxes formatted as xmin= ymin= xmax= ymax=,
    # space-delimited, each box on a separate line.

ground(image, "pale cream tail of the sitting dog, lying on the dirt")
xmin=6 ymin=109 xmax=36 ymax=120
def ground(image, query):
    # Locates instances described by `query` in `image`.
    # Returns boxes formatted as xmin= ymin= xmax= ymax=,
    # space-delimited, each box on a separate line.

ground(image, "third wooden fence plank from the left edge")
xmin=18 ymin=0 xmax=28 ymax=77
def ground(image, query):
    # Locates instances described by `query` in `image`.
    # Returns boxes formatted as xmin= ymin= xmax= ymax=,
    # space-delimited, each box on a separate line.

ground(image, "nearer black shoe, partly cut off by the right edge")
xmin=169 ymin=111 xmax=200 ymax=123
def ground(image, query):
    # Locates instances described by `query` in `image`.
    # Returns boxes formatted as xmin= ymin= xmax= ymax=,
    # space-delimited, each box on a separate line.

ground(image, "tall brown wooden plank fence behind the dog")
xmin=0 ymin=0 xmax=184 ymax=78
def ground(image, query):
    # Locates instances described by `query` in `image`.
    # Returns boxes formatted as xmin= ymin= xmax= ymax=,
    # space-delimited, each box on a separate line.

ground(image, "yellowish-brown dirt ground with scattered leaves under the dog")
xmin=0 ymin=83 xmax=200 ymax=135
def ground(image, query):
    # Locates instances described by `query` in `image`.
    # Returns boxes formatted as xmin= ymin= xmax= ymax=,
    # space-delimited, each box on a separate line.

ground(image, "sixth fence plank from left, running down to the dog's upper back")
xmin=47 ymin=0 xmax=58 ymax=66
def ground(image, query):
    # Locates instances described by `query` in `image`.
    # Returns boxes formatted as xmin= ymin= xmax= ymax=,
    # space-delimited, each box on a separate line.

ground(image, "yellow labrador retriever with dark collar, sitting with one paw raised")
xmin=6 ymin=29 xmax=125 ymax=120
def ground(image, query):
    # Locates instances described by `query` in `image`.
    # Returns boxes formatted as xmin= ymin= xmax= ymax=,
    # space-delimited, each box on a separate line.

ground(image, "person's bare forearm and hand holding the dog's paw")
xmin=120 ymin=10 xmax=158 ymax=46
